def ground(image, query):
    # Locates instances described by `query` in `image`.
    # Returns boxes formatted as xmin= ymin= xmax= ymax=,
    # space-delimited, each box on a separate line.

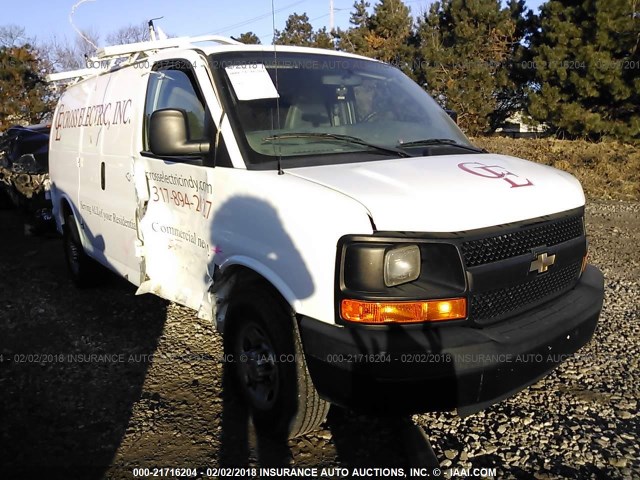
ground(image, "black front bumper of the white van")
xmin=300 ymin=266 xmax=604 ymax=415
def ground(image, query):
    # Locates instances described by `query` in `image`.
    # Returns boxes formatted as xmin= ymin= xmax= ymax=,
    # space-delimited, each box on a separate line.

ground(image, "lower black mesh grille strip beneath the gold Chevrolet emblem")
xmin=469 ymin=262 xmax=581 ymax=324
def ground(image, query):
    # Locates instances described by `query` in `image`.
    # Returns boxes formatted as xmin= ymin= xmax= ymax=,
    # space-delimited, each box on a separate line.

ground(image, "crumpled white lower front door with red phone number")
xmin=134 ymin=157 xmax=215 ymax=319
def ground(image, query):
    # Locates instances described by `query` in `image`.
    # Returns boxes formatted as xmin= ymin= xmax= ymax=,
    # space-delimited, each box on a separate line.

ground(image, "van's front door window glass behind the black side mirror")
xmin=144 ymin=62 xmax=210 ymax=150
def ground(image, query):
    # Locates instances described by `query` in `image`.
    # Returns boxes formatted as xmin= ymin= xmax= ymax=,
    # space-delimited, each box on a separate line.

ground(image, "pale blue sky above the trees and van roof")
xmin=0 ymin=0 xmax=542 ymax=46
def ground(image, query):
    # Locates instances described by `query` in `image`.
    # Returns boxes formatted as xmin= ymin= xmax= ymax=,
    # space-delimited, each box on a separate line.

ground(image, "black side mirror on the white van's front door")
xmin=149 ymin=108 xmax=209 ymax=157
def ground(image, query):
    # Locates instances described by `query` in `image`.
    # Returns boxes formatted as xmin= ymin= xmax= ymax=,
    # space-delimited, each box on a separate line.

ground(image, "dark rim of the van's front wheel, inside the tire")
xmin=237 ymin=323 xmax=279 ymax=410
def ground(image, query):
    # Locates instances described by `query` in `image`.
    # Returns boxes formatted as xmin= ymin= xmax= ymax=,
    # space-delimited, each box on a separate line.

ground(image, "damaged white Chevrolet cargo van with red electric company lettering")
xmin=50 ymin=37 xmax=603 ymax=436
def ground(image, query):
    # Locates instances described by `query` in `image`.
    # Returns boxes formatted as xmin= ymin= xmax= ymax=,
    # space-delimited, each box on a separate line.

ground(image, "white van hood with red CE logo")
xmin=286 ymin=154 xmax=585 ymax=232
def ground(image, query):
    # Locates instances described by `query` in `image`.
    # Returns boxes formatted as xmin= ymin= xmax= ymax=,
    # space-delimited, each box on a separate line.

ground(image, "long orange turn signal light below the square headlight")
xmin=340 ymin=298 xmax=467 ymax=324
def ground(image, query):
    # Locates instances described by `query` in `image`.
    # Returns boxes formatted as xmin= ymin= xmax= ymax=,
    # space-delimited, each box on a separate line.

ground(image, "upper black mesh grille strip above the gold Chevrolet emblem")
xmin=462 ymin=214 xmax=584 ymax=267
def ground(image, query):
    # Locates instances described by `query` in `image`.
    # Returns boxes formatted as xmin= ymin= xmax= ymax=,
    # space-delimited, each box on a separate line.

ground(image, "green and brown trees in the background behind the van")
xmin=5 ymin=0 xmax=640 ymax=141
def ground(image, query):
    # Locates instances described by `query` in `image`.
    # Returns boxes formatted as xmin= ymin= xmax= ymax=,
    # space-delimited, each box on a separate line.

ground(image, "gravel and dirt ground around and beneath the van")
xmin=0 ymin=202 xmax=640 ymax=479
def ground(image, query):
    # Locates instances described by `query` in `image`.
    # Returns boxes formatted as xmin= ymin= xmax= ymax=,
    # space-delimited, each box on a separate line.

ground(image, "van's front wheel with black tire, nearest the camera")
xmin=224 ymin=283 xmax=329 ymax=438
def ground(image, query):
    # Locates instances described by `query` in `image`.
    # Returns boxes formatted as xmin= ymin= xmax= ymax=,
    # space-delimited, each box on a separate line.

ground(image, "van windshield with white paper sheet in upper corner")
xmin=210 ymin=51 xmax=478 ymax=168
